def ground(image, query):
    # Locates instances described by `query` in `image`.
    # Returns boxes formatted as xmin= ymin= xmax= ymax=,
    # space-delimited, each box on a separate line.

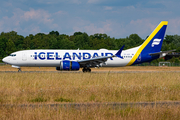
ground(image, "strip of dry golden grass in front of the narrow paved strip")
xmin=0 ymin=106 xmax=180 ymax=120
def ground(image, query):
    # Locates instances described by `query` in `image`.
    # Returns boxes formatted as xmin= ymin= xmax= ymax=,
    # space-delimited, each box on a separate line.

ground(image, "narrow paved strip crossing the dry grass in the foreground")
xmin=0 ymin=101 xmax=180 ymax=109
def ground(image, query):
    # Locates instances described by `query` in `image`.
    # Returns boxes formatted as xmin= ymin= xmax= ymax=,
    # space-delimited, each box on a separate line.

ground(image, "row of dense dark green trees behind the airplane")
xmin=0 ymin=31 xmax=180 ymax=59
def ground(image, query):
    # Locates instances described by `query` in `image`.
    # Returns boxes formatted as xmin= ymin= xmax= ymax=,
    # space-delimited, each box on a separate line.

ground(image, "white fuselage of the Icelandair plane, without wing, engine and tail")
xmin=3 ymin=47 xmax=139 ymax=67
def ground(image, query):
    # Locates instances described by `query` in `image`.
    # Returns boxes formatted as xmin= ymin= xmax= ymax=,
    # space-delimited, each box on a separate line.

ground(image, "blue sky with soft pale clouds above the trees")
xmin=0 ymin=0 xmax=180 ymax=39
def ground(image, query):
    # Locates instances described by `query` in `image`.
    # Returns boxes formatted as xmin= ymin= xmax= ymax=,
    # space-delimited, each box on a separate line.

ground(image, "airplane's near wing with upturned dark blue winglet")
xmin=77 ymin=45 xmax=124 ymax=67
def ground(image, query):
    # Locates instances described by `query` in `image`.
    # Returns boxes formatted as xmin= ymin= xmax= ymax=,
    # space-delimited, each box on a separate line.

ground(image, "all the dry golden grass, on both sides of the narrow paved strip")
xmin=0 ymin=66 xmax=180 ymax=119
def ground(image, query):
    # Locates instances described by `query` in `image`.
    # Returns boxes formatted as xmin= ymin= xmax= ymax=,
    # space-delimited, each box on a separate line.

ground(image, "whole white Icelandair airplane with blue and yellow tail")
xmin=2 ymin=21 xmax=172 ymax=72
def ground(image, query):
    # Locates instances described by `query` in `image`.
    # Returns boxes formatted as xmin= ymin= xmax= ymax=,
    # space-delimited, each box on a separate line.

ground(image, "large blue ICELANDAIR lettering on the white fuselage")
xmin=34 ymin=52 xmax=113 ymax=60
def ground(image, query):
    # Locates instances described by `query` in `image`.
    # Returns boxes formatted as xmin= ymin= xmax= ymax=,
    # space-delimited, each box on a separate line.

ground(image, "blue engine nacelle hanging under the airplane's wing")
xmin=56 ymin=61 xmax=80 ymax=71
